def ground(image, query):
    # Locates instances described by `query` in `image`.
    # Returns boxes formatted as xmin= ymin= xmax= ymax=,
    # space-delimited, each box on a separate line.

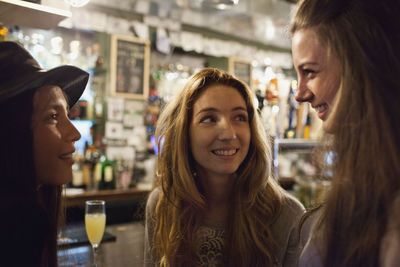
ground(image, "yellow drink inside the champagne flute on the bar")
xmin=85 ymin=213 xmax=106 ymax=247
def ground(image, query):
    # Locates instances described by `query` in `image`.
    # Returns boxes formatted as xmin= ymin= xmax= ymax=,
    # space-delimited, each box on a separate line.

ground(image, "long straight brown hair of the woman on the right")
xmin=291 ymin=0 xmax=400 ymax=266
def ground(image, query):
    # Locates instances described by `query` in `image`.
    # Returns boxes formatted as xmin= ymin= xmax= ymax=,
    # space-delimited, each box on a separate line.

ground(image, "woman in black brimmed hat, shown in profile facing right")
xmin=0 ymin=42 xmax=88 ymax=266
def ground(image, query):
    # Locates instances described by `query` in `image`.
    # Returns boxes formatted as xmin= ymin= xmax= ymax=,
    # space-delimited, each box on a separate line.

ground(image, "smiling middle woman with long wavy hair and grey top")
xmin=145 ymin=68 xmax=304 ymax=267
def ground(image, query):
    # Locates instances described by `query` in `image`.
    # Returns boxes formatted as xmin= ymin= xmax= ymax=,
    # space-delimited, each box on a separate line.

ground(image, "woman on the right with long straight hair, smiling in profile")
xmin=291 ymin=0 xmax=400 ymax=267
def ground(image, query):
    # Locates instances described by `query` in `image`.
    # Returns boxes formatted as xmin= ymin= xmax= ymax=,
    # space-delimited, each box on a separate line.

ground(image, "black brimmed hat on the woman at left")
xmin=0 ymin=41 xmax=89 ymax=107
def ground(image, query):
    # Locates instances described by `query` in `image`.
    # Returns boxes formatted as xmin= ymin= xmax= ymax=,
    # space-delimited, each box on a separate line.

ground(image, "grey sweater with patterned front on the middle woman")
xmin=144 ymin=188 xmax=304 ymax=267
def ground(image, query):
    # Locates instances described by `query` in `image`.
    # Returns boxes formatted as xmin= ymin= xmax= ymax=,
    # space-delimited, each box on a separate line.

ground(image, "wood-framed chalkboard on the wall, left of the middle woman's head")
xmin=110 ymin=35 xmax=150 ymax=100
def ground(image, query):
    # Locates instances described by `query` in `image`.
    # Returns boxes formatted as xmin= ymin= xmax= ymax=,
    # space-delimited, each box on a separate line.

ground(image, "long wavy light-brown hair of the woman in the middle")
xmin=152 ymin=68 xmax=282 ymax=267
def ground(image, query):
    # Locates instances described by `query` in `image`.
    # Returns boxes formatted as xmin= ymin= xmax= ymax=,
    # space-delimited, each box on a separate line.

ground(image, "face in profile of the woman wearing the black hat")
xmin=32 ymin=86 xmax=81 ymax=185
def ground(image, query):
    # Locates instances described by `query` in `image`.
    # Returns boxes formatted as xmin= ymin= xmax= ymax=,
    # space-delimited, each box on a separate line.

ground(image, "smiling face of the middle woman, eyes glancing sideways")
xmin=189 ymin=84 xmax=251 ymax=180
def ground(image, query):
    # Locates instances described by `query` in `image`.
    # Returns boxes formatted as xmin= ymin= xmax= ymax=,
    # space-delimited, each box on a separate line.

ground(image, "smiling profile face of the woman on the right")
xmin=292 ymin=29 xmax=341 ymax=121
